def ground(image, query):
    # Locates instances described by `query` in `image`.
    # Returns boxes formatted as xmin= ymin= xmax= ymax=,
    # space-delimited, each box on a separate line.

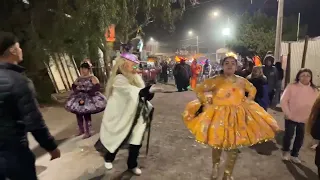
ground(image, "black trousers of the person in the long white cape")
xmin=104 ymin=144 xmax=141 ymax=169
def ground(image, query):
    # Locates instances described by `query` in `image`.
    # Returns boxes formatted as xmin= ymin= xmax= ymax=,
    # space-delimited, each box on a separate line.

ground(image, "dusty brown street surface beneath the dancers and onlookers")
xmin=30 ymin=83 xmax=317 ymax=180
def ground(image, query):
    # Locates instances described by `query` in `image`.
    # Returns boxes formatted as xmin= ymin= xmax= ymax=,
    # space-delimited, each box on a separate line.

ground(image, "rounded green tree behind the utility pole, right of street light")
xmin=227 ymin=11 xmax=307 ymax=57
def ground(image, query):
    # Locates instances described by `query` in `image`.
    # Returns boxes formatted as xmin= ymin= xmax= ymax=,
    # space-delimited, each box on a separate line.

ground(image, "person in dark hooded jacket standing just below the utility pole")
xmin=263 ymin=55 xmax=278 ymax=105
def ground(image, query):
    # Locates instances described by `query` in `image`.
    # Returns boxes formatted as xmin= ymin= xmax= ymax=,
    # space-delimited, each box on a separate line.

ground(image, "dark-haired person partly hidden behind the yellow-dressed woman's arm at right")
xmin=247 ymin=66 xmax=269 ymax=111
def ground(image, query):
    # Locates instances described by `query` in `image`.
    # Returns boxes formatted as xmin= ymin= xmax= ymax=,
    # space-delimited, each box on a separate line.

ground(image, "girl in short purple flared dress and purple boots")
xmin=65 ymin=62 xmax=106 ymax=139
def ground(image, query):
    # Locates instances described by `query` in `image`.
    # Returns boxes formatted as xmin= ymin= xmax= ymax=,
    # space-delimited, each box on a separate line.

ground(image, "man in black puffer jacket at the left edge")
xmin=0 ymin=32 xmax=60 ymax=180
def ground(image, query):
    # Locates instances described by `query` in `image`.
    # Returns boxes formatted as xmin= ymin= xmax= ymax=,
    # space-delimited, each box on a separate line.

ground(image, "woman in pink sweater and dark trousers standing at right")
xmin=280 ymin=69 xmax=318 ymax=163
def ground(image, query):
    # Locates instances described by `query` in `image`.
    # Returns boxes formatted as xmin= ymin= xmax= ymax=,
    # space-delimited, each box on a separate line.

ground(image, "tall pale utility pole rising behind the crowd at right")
xmin=274 ymin=0 xmax=284 ymax=62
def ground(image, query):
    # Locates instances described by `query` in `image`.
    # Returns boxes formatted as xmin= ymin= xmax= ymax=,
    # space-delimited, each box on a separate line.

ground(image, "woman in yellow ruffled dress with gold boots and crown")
xmin=183 ymin=57 xmax=279 ymax=180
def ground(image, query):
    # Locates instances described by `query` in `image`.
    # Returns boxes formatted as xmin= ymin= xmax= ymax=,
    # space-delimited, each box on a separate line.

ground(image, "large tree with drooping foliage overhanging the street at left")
xmin=0 ymin=0 xmax=184 ymax=102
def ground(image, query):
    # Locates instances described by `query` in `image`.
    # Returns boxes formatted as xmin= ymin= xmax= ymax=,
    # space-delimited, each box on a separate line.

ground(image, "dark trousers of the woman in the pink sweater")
xmin=282 ymin=119 xmax=305 ymax=157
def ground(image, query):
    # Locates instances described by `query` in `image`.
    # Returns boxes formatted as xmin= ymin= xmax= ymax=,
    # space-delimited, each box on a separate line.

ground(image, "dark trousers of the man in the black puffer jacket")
xmin=0 ymin=147 xmax=38 ymax=180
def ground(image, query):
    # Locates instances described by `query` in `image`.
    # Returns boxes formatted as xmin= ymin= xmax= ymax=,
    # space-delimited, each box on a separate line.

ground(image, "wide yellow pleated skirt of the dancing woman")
xmin=183 ymin=100 xmax=280 ymax=150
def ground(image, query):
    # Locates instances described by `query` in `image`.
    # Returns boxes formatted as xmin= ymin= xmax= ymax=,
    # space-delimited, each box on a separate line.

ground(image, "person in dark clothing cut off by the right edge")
xmin=307 ymin=96 xmax=320 ymax=179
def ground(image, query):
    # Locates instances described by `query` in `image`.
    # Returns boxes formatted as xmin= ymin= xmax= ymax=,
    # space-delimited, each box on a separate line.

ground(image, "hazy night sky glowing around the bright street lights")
xmin=145 ymin=0 xmax=320 ymax=52
